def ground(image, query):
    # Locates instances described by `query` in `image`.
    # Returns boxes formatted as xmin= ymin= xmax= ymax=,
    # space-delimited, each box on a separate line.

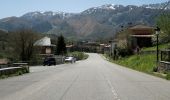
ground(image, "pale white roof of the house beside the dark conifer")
xmin=34 ymin=37 xmax=55 ymax=46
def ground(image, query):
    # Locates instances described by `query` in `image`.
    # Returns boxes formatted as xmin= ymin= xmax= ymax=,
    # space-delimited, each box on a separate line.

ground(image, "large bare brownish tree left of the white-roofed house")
xmin=9 ymin=30 xmax=38 ymax=61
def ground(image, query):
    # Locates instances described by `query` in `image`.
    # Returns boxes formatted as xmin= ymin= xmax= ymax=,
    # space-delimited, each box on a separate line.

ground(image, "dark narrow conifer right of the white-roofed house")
xmin=55 ymin=35 xmax=66 ymax=55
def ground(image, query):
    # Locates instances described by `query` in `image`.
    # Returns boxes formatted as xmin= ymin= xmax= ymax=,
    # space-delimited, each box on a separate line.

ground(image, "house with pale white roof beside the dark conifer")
xmin=34 ymin=37 xmax=56 ymax=55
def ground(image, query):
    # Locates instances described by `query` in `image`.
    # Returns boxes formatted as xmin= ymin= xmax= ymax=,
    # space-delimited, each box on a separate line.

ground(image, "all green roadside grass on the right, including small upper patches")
xmin=105 ymin=43 xmax=170 ymax=80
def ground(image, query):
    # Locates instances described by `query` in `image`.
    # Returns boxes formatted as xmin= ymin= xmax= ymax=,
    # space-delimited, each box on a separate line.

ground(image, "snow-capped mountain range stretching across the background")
xmin=0 ymin=3 xmax=170 ymax=39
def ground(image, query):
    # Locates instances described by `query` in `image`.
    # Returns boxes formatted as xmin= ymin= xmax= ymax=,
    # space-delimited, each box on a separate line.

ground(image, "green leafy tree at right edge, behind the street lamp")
xmin=157 ymin=13 xmax=170 ymax=42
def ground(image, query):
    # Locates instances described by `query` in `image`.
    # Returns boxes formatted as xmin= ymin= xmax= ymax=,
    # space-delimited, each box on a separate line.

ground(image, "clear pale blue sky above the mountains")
xmin=0 ymin=0 xmax=168 ymax=19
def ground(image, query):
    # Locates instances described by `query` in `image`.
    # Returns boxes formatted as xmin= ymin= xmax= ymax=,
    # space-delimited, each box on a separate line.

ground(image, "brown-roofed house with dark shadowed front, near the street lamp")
xmin=129 ymin=25 xmax=154 ymax=48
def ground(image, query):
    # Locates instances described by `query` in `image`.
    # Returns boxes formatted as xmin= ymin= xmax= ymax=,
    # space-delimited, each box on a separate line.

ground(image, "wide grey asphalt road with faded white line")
xmin=0 ymin=54 xmax=170 ymax=100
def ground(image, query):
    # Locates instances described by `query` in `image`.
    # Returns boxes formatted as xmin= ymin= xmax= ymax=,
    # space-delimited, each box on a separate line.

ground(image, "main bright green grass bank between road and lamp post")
xmin=114 ymin=54 xmax=156 ymax=73
